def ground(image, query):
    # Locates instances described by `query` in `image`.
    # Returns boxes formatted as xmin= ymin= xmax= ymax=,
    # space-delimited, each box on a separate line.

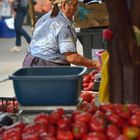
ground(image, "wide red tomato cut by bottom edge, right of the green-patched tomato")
xmin=82 ymin=132 xmax=107 ymax=140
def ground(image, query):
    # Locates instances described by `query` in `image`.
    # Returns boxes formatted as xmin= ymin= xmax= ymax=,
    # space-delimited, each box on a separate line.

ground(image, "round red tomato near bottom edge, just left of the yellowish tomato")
xmin=106 ymin=124 xmax=120 ymax=140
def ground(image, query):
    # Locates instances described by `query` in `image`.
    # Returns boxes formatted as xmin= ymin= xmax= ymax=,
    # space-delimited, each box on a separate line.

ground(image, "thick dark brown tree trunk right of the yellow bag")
xmin=105 ymin=0 xmax=140 ymax=103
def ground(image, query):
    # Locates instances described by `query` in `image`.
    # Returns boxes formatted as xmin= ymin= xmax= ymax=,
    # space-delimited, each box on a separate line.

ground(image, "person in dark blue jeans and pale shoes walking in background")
xmin=9 ymin=0 xmax=31 ymax=52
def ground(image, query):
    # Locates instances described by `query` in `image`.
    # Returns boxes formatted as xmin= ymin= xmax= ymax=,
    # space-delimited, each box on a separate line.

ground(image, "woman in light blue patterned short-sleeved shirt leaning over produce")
xmin=23 ymin=0 xmax=99 ymax=68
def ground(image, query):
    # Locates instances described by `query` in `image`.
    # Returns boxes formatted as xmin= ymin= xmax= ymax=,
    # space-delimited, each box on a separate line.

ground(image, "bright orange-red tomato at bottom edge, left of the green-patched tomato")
xmin=57 ymin=131 xmax=74 ymax=140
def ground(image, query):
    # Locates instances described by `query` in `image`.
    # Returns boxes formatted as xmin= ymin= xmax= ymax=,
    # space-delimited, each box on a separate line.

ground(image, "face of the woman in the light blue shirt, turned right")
xmin=62 ymin=0 xmax=78 ymax=20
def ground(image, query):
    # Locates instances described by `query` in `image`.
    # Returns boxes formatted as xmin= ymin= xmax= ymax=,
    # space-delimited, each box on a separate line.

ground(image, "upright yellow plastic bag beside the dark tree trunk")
xmin=99 ymin=51 xmax=109 ymax=103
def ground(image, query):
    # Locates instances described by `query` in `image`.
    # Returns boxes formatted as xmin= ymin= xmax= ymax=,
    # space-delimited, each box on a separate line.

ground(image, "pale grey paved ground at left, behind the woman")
xmin=0 ymin=27 xmax=83 ymax=97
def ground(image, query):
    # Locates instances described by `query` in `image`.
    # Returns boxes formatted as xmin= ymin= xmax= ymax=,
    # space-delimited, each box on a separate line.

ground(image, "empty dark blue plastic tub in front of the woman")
xmin=9 ymin=66 xmax=87 ymax=106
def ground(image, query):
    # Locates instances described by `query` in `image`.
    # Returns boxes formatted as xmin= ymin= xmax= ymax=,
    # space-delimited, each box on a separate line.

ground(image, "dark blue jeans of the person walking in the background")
xmin=14 ymin=10 xmax=31 ymax=46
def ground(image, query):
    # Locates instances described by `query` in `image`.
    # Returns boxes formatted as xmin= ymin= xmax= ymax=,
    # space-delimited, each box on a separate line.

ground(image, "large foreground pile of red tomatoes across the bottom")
xmin=0 ymin=102 xmax=140 ymax=140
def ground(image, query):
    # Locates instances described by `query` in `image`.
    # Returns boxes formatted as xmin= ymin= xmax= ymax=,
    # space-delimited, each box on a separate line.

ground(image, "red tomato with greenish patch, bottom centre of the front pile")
xmin=72 ymin=121 xmax=88 ymax=139
